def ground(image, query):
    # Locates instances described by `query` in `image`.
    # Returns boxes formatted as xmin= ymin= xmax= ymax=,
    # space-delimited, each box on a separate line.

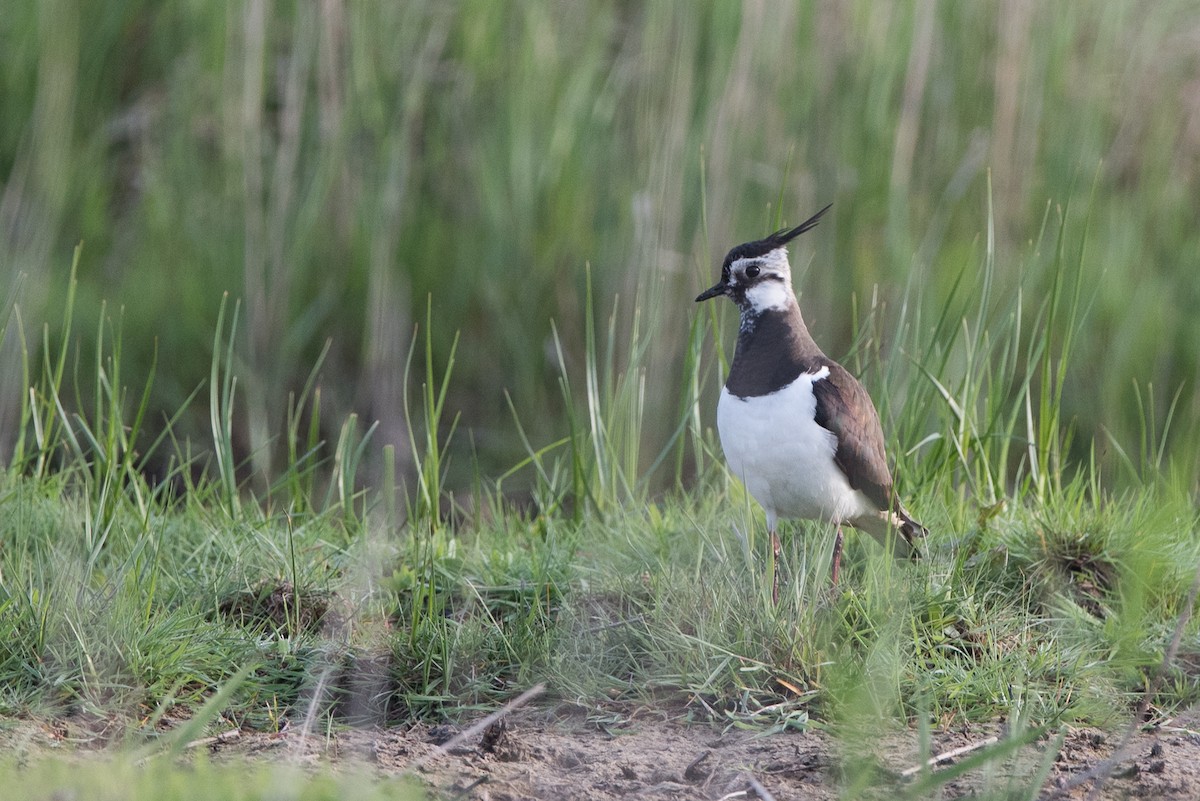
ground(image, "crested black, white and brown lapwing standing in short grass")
xmin=696 ymin=204 xmax=928 ymax=603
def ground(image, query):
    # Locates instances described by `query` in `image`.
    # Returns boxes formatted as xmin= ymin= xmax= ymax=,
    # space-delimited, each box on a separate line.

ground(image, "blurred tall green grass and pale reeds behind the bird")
xmin=0 ymin=0 xmax=1200 ymax=491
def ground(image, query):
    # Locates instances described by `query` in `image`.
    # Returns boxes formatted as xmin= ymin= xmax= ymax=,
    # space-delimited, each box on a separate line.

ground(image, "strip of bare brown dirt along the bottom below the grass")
xmin=11 ymin=707 xmax=1200 ymax=801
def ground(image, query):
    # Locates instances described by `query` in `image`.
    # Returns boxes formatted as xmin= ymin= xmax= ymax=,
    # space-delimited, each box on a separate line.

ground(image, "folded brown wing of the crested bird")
xmin=812 ymin=360 xmax=892 ymax=510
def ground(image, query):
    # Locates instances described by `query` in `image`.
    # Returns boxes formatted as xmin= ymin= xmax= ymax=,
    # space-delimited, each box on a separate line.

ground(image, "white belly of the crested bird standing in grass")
xmin=716 ymin=368 xmax=876 ymax=530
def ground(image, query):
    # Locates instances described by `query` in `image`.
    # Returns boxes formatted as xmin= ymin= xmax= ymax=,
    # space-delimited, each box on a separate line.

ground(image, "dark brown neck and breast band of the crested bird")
xmin=725 ymin=300 xmax=827 ymax=398
